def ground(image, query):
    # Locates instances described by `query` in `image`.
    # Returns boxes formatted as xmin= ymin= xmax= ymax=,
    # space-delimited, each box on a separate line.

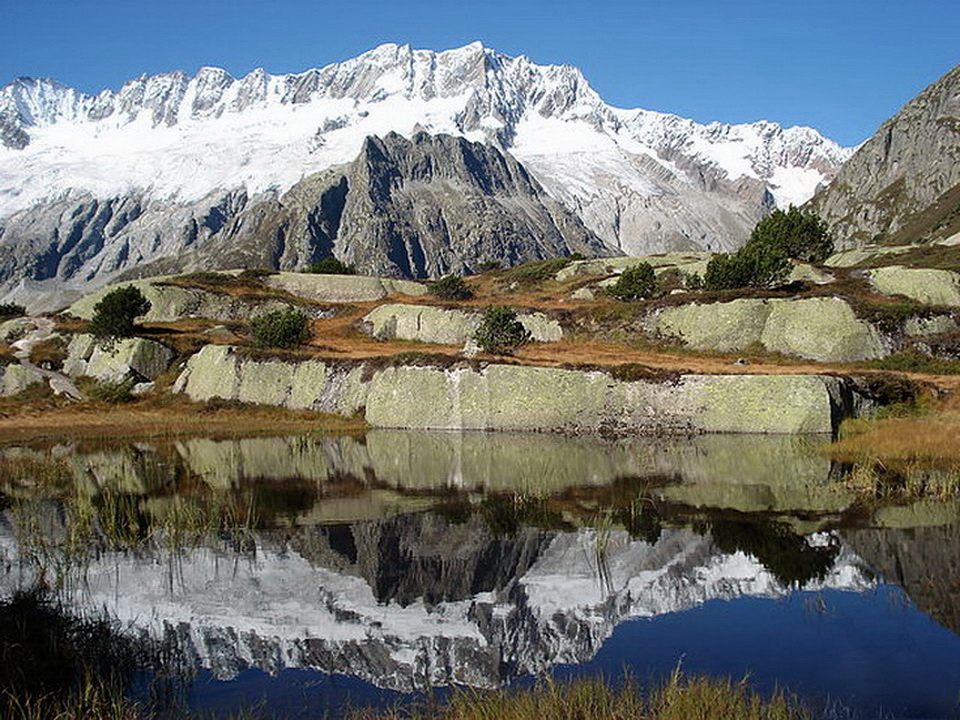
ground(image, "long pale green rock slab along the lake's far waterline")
xmin=175 ymin=345 xmax=869 ymax=434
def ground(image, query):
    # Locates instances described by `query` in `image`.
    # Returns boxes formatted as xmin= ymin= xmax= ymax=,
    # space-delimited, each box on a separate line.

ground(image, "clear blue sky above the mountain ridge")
xmin=0 ymin=0 xmax=960 ymax=144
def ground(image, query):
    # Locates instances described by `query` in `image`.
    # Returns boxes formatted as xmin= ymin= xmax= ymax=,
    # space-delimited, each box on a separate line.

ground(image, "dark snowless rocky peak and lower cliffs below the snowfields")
xmin=0 ymin=132 xmax=614 ymax=309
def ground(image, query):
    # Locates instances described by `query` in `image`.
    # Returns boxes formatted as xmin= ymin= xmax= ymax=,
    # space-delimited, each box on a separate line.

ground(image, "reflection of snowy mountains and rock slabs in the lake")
xmin=0 ymin=431 xmax=960 ymax=716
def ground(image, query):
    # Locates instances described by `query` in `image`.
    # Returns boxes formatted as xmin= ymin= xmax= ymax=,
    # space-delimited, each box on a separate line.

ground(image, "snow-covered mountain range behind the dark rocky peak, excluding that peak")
xmin=0 ymin=43 xmax=849 ymax=306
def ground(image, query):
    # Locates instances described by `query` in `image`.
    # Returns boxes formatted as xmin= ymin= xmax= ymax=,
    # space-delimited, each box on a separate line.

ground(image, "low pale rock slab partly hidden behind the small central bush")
xmin=363 ymin=303 xmax=563 ymax=345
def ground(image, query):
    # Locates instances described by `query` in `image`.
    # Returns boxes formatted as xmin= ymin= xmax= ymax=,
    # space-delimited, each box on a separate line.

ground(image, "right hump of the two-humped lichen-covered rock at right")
xmin=760 ymin=298 xmax=888 ymax=362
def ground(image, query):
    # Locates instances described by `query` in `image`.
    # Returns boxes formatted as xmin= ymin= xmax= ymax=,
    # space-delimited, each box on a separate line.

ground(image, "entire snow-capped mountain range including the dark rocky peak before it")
xmin=0 ymin=44 xmax=849 ymax=309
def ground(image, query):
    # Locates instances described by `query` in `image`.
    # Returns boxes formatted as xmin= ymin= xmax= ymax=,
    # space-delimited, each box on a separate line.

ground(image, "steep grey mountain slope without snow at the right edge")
xmin=810 ymin=65 xmax=960 ymax=247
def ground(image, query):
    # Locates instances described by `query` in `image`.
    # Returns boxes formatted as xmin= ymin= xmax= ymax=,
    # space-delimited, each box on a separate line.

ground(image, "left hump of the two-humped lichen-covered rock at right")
xmin=647 ymin=299 xmax=771 ymax=351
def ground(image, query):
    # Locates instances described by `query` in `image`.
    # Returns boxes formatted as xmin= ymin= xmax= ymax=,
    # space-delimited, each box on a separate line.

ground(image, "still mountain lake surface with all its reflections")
xmin=0 ymin=431 xmax=960 ymax=718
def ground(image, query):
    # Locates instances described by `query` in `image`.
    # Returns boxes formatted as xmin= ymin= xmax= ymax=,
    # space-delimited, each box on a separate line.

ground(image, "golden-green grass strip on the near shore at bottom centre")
xmin=354 ymin=671 xmax=810 ymax=720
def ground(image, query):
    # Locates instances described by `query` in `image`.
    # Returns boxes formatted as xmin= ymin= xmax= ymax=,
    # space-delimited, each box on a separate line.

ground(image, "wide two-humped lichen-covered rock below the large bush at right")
xmin=647 ymin=297 xmax=890 ymax=362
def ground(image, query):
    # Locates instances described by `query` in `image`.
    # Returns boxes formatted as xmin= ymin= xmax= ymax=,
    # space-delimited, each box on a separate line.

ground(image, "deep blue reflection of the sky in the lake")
xmin=167 ymin=586 xmax=960 ymax=718
